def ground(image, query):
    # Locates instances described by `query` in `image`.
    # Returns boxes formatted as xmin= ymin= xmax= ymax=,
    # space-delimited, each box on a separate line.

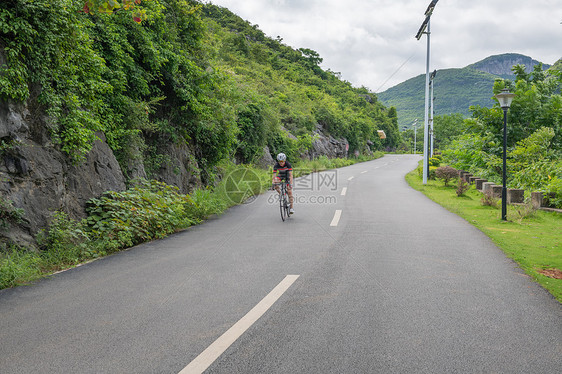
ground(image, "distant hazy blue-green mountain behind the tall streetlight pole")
xmin=377 ymin=53 xmax=550 ymax=128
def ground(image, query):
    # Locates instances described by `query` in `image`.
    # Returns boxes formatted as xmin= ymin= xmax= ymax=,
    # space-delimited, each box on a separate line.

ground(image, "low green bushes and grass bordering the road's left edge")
xmin=0 ymin=153 xmax=383 ymax=289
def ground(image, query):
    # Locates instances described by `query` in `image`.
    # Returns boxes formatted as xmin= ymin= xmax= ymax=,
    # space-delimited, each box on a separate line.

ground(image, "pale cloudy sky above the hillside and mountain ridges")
xmin=210 ymin=0 xmax=562 ymax=92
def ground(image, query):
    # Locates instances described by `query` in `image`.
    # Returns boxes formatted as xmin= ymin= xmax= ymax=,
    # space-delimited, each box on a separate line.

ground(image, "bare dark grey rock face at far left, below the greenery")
xmin=0 ymin=102 xmax=125 ymax=247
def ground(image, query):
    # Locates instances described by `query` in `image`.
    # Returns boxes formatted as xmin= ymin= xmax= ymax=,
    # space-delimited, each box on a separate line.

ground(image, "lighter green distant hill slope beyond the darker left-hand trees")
xmin=203 ymin=5 xmax=400 ymax=153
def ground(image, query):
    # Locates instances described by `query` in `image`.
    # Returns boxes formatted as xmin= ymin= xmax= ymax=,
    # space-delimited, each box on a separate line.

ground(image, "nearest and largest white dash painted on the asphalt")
xmin=179 ymin=275 xmax=299 ymax=374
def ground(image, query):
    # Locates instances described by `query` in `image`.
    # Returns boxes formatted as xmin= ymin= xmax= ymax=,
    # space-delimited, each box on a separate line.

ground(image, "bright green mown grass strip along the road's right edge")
xmin=406 ymin=171 xmax=562 ymax=302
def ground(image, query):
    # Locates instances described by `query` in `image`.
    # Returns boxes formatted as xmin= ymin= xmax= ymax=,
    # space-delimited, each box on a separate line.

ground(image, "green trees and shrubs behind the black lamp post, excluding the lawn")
xmin=403 ymin=64 xmax=562 ymax=209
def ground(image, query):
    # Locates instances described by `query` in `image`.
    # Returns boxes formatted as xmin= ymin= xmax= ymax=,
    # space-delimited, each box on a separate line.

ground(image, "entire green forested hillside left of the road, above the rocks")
xmin=0 ymin=0 xmax=400 ymax=179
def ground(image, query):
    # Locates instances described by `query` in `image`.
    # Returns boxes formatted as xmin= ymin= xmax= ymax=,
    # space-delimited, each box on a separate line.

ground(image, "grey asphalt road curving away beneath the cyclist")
xmin=0 ymin=156 xmax=562 ymax=374
